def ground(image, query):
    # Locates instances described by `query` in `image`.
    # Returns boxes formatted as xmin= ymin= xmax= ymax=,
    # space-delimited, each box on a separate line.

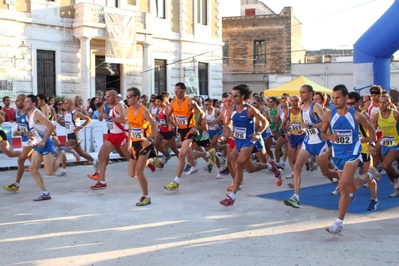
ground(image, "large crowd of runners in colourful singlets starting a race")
xmin=0 ymin=83 xmax=399 ymax=234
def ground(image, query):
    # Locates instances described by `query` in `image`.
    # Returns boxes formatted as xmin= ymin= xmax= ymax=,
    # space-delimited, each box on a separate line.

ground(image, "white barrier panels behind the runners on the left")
xmin=0 ymin=120 xmax=125 ymax=168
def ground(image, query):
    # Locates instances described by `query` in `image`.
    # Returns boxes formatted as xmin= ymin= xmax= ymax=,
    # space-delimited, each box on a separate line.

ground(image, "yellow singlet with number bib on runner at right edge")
xmin=378 ymin=110 xmax=399 ymax=147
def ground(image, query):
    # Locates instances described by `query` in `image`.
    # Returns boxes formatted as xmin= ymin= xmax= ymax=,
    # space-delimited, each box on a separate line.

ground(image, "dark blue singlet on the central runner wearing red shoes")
xmin=231 ymin=104 xmax=255 ymax=141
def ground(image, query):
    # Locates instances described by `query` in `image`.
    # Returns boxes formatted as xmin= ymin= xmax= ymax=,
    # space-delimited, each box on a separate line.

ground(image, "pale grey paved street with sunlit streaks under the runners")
xmin=0 ymin=158 xmax=399 ymax=266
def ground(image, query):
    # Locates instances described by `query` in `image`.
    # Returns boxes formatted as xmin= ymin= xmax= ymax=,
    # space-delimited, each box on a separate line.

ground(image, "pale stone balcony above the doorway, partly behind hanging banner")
xmin=73 ymin=3 xmax=152 ymax=38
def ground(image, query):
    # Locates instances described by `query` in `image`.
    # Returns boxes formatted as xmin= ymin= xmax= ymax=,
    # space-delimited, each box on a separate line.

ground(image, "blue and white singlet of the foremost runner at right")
xmin=330 ymin=108 xmax=361 ymax=159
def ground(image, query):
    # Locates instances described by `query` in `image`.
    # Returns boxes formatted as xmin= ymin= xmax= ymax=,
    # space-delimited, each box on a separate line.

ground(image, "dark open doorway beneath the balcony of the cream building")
xmin=95 ymin=55 xmax=121 ymax=93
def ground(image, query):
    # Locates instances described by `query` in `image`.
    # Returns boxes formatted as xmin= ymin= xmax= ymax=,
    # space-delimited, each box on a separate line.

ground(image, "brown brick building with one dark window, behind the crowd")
xmin=222 ymin=0 xmax=305 ymax=92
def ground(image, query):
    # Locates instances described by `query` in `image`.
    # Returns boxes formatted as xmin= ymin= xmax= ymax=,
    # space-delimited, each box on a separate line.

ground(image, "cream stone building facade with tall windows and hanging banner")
xmin=0 ymin=0 xmax=223 ymax=102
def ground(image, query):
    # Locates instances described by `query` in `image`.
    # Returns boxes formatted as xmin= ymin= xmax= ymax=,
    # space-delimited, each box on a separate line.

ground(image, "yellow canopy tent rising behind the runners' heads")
xmin=263 ymin=76 xmax=332 ymax=97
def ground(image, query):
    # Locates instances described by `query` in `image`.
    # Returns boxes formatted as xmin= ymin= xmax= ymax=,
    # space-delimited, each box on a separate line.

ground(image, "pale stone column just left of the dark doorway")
xmin=79 ymin=36 xmax=91 ymax=104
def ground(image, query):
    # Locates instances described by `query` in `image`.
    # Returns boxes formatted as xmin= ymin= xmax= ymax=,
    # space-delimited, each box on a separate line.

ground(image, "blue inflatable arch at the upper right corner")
xmin=353 ymin=0 xmax=399 ymax=94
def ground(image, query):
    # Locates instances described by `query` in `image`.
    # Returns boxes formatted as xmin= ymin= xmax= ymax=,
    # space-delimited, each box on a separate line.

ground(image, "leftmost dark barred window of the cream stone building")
xmin=37 ymin=50 xmax=56 ymax=95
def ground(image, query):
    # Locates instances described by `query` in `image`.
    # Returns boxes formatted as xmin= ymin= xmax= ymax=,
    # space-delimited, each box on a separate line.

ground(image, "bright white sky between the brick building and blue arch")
xmin=261 ymin=0 xmax=399 ymax=50
